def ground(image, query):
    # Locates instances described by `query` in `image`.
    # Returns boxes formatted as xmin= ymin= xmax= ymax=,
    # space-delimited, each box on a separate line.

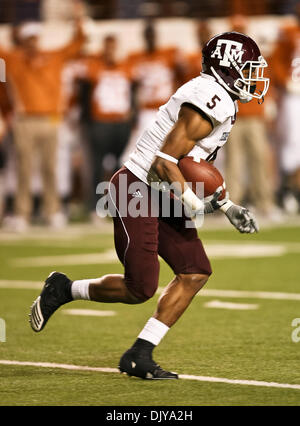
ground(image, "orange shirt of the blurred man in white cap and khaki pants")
xmin=0 ymin=33 xmax=84 ymax=115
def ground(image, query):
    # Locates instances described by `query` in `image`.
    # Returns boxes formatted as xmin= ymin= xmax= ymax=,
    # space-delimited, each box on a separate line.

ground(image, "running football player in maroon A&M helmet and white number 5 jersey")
xmin=30 ymin=32 xmax=269 ymax=379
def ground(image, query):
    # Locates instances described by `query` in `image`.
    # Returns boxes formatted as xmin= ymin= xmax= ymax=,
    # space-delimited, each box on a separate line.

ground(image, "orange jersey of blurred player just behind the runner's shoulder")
xmin=129 ymin=48 xmax=177 ymax=109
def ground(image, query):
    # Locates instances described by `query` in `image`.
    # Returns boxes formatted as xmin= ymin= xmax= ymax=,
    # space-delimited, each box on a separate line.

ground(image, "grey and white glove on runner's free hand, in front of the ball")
xmin=223 ymin=204 xmax=259 ymax=234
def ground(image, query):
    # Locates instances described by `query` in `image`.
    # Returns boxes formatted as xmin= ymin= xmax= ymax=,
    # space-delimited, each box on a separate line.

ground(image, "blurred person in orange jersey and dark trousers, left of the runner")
xmin=83 ymin=35 xmax=133 ymax=220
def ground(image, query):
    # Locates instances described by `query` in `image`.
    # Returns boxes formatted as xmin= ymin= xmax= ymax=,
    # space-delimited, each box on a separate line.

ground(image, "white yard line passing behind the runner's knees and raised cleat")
xmin=0 ymin=280 xmax=300 ymax=301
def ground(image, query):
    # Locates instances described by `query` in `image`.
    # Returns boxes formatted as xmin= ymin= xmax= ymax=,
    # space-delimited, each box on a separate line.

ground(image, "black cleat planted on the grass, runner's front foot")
xmin=119 ymin=349 xmax=178 ymax=380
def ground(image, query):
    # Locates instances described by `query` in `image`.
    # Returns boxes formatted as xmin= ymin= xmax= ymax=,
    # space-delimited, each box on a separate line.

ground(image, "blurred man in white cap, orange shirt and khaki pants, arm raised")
xmin=0 ymin=16 xmax=84 ymax=231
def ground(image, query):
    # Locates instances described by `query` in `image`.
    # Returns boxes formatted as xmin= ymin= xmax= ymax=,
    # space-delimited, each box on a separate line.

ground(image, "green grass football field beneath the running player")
xmin=0 ymin=220 xmax=300 ymax=406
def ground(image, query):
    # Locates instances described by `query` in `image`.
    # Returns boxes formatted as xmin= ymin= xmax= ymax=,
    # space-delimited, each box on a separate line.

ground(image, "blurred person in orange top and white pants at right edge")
xmin=272 ymin=2 xmax=300 ymax=213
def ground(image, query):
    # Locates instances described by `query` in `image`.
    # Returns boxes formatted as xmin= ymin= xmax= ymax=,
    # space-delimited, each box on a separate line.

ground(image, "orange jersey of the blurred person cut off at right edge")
xmin=270 ymin=25 xmax=300 ymax=88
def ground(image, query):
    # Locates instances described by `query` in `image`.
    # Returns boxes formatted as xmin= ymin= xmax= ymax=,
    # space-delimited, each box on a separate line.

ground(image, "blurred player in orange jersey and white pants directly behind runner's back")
xmin=123 ymin=20 xmax=186 ymax=161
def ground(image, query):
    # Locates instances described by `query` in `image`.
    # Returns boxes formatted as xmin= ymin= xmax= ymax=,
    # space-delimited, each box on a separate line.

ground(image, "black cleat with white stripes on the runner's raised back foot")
xmin=29 ymin=272 xmax=73 ymax=333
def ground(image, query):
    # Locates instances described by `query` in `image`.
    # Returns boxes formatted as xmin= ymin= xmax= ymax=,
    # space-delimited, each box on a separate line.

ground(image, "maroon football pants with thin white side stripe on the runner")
xmin=109 ymin=167 xmax=212 ymax=300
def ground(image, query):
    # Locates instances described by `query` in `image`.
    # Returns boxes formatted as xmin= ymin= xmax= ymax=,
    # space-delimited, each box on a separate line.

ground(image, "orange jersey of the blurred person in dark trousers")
xmin=85 ymin=58 xmax=132 ymax=122
